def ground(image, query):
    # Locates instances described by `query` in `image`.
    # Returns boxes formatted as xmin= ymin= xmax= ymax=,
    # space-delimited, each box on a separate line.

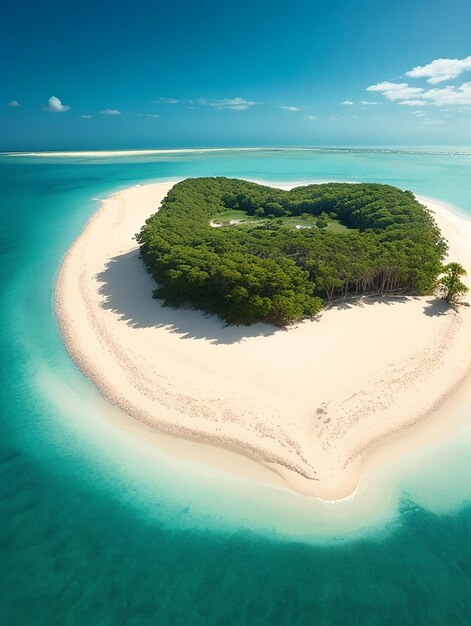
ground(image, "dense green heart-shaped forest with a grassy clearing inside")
xmin=137 ymin=177 xmax=447 ymax=326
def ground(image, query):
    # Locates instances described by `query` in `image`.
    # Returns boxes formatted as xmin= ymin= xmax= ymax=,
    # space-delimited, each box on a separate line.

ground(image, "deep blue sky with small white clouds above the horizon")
xmin=0 ymin=0 xmax=471 ymax=150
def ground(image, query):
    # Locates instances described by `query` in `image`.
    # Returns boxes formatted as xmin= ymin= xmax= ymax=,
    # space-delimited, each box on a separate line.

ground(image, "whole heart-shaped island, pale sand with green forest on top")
xmin=56 ymin=178 xmax=471 ymax=499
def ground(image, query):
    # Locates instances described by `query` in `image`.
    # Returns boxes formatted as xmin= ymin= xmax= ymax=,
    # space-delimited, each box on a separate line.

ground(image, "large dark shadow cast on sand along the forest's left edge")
xmin=96 ymin=250 xmax=282 ymax=344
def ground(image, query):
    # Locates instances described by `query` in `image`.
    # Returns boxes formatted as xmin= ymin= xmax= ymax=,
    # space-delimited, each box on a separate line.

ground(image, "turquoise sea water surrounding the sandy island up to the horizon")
xmin=0 ymin=149 xmax=471 ymax=626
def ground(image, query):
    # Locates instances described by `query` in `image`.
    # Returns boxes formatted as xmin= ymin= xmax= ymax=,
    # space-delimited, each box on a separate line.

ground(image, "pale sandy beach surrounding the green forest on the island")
xmin=56 ymin=182 xmax=471 ymax=499
